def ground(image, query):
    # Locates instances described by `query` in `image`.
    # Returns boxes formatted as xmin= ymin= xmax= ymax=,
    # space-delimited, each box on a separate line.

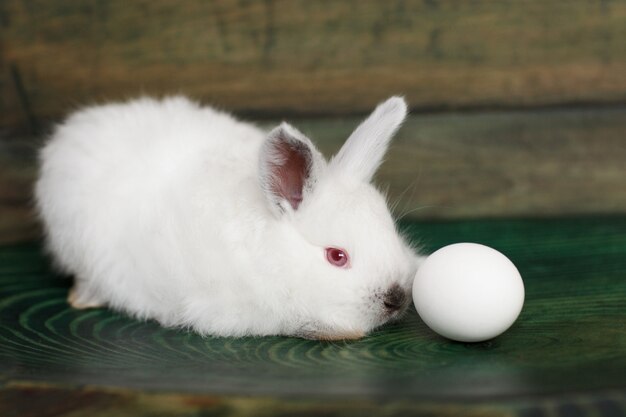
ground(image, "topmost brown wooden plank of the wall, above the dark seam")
xmin=0 ymin=0 xmax=626 ymax=127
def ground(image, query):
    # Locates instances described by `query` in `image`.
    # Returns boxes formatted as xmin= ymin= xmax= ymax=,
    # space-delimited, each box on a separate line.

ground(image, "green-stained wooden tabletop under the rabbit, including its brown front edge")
xmin=0 ymin=217 xmax=626 ymax=417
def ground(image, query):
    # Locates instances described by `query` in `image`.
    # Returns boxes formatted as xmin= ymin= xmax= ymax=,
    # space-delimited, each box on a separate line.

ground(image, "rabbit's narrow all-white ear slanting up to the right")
xmin=331 ymin=97 xmax=407 ymax=182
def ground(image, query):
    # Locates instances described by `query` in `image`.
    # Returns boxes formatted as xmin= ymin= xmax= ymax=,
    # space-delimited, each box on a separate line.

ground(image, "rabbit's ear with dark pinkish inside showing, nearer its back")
xmin=259 ymin=123 xmax=325 ymax=215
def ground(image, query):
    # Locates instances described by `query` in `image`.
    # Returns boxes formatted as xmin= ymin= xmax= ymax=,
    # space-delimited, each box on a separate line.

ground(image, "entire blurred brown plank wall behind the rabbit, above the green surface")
xmin=0 ymin=0 xmax=626 ymax=242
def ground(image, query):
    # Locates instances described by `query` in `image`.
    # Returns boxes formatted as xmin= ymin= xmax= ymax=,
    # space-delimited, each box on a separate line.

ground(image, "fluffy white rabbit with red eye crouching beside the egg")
xmin=36 ymin=97 xmax=421 ymax=340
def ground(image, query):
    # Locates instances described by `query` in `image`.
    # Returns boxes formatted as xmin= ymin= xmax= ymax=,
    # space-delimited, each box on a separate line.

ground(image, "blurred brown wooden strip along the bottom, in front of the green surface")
xmin=0 ymin=383 xmax=626 ymax=417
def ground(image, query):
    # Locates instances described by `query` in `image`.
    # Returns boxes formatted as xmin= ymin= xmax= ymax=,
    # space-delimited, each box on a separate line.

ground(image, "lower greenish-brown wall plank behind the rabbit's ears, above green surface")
xmin=0 ymin=107 xmax=626 ymax=243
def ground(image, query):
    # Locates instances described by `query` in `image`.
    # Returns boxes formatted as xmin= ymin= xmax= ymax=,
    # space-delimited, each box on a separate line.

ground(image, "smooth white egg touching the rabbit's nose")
xmin=413 ymin=243 xmax=524 ymax=342
